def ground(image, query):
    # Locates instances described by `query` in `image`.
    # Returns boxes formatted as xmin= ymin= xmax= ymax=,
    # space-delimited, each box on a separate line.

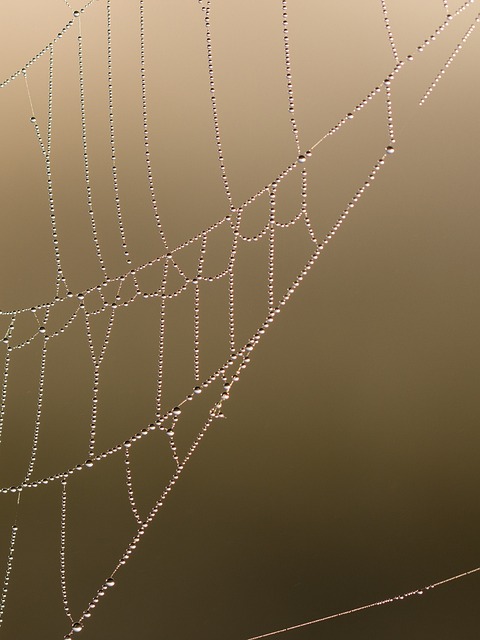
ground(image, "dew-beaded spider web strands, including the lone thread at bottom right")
xmin=0 ymin=0 xmax=480 ymax=640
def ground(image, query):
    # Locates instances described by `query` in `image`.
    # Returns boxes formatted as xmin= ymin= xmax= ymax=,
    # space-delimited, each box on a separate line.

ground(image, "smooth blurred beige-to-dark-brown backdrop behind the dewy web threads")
xmin=0 ymin=0 xmax=480 ymax=640
